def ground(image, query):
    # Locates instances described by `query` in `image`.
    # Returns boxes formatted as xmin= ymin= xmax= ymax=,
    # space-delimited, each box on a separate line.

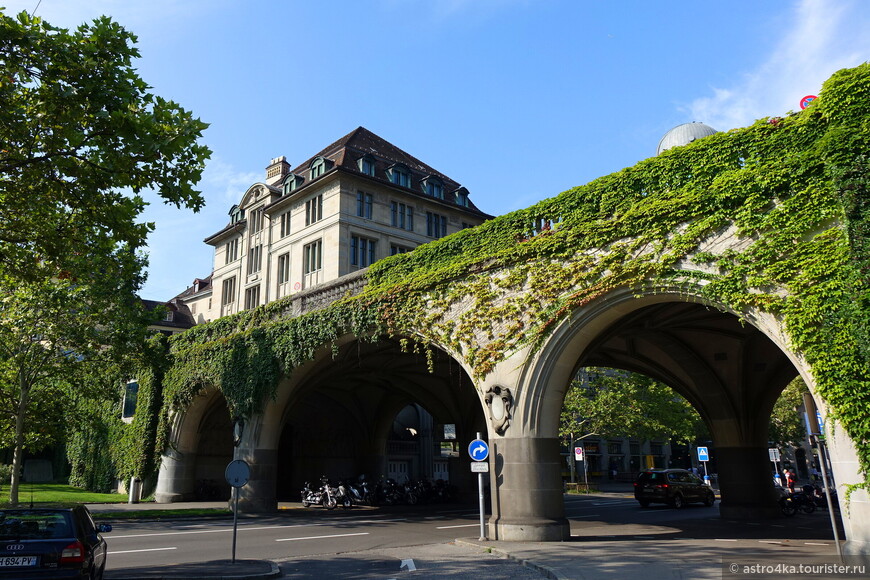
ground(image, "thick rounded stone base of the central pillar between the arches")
xmin=490 ymin=437 xmax=571 ymax=542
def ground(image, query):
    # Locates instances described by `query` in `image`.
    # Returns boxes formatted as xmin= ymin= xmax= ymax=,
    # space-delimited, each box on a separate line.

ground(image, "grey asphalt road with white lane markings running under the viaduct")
xmin=106 ymin=493 xmax=833 ymax=579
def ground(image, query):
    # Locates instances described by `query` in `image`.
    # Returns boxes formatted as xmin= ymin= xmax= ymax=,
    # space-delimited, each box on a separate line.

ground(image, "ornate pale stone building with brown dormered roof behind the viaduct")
xmin=176 ymin=127 xmax=491 ymax=324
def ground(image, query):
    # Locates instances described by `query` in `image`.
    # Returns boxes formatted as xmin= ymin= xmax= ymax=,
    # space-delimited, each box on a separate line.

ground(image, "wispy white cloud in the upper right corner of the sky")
xmin=685 ymin=0 xmax=870 ymax=130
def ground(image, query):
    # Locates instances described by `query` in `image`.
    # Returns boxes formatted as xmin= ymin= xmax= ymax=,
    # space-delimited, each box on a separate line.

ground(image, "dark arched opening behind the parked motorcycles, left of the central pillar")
xmin=276 ymin=339 xmax=485 ymax=501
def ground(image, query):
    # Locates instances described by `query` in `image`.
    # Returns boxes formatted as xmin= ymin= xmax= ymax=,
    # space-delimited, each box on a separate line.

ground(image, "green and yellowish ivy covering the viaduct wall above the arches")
xmin=73 ymin=64 xmax=870 ymax=490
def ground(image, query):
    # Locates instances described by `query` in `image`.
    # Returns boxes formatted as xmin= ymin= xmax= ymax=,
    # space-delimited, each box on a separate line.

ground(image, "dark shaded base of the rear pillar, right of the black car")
xmin=713 ymin=445 xmax=782 ymax=519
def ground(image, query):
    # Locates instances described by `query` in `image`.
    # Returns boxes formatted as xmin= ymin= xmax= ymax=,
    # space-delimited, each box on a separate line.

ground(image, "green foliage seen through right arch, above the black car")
xmin=559 ymin=368 xmax=706 ymax=443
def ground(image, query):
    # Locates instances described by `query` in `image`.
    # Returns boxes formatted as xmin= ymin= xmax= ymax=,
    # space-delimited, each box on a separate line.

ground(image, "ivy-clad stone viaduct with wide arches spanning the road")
xmin=157 ymin=67 xmax=870 ymax=553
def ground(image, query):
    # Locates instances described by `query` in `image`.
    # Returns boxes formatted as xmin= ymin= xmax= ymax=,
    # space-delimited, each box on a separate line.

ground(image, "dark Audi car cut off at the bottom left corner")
xmin=0 ymin=505 xmax=112 ymax=580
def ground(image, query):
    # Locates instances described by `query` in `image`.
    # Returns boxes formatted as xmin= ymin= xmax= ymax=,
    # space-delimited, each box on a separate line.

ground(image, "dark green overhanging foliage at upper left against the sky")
xmin=0 ymin=12 xmax=210 ymax=279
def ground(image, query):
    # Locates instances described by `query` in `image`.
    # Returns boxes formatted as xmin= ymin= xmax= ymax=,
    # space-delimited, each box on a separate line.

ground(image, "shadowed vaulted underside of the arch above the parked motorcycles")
xmin=230 ymin=335 xmax=483 ymax=511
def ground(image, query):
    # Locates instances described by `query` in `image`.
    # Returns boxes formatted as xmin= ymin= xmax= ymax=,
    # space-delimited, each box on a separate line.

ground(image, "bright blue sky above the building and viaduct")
xmin=0 ymin=0 xmax=870 ymax=300
